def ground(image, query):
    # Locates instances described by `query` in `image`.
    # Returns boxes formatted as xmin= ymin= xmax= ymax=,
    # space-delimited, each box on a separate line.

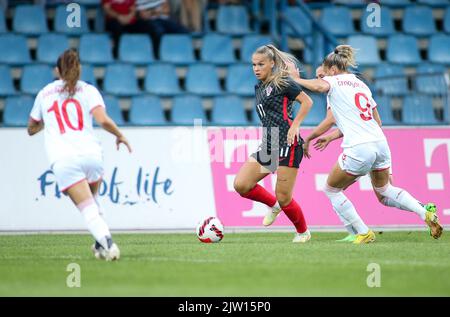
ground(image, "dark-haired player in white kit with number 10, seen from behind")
xmin=28 ymin=49 xmax=131 ymax=261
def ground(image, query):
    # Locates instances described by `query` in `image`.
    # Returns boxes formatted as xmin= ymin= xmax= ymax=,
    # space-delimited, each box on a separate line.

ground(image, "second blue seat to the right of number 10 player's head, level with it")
xmin=103 ymin=63 xmax=139 ymax=96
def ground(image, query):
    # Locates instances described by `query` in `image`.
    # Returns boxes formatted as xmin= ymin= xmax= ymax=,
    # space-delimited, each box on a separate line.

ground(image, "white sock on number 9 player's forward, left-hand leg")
xmin=324 ymin=185 xmax=369 ymax=234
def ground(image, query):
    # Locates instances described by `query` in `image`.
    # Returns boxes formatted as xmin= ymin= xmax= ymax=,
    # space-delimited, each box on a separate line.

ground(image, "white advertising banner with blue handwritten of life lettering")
xmin=0 ymin=127 xmax=215 ymax=231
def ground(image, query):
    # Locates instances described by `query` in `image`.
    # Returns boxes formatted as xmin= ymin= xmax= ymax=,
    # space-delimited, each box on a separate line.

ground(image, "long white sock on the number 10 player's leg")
xmin=77 ymin=198 xmax=111 ymax=250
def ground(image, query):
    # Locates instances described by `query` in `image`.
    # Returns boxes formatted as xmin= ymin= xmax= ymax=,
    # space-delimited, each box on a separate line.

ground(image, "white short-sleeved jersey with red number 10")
xmin=30 ymin=80 xmax=105 ymax=164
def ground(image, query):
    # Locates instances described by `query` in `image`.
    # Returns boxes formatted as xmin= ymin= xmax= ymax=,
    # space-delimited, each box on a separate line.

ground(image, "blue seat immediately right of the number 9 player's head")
xmin=348 ymin=35 xmax=380 ymax=66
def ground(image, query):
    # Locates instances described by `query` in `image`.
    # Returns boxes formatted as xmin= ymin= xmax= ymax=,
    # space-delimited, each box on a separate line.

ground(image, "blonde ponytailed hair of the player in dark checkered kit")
xmin=254 ymin=44 xmax=300 ymax=89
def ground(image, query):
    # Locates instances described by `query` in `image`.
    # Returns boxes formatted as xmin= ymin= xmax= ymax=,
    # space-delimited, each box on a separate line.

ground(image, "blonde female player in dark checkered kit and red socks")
xmin=234 ymin=45 xmax=312 ymax=243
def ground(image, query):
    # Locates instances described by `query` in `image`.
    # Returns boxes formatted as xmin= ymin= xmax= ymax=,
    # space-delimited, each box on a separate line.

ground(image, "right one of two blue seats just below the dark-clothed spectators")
xmin=159 ymin=34 xmax=195 ymax=65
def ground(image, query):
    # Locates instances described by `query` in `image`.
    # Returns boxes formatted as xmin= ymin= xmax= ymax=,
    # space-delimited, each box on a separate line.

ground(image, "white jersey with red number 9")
xmin=323 ymin=74 xmax=386 ymax=148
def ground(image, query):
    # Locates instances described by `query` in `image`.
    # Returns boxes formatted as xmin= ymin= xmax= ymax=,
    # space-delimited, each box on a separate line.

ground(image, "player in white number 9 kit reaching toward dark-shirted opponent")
xmin=290 ymin=45 xmax=443 ymax=244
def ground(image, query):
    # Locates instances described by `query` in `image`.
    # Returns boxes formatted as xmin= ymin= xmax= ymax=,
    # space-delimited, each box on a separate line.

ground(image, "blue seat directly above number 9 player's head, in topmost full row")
xmin=320 ymin=6 xmax=355 ymax=37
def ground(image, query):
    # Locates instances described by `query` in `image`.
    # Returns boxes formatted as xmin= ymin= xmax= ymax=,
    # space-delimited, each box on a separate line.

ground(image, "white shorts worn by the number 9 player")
xmin=338 ymin=141 xmax=391 ymax=176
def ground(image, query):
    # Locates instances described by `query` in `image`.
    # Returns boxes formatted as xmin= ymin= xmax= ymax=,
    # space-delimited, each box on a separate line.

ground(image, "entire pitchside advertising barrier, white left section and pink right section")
xmin=0 ymin=127 xmax=450 ymax=231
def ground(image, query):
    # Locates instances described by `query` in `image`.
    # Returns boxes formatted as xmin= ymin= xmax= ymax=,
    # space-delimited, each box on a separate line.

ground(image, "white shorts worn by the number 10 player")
xmin=52 ymin=156 xmax=103 ymax=192
